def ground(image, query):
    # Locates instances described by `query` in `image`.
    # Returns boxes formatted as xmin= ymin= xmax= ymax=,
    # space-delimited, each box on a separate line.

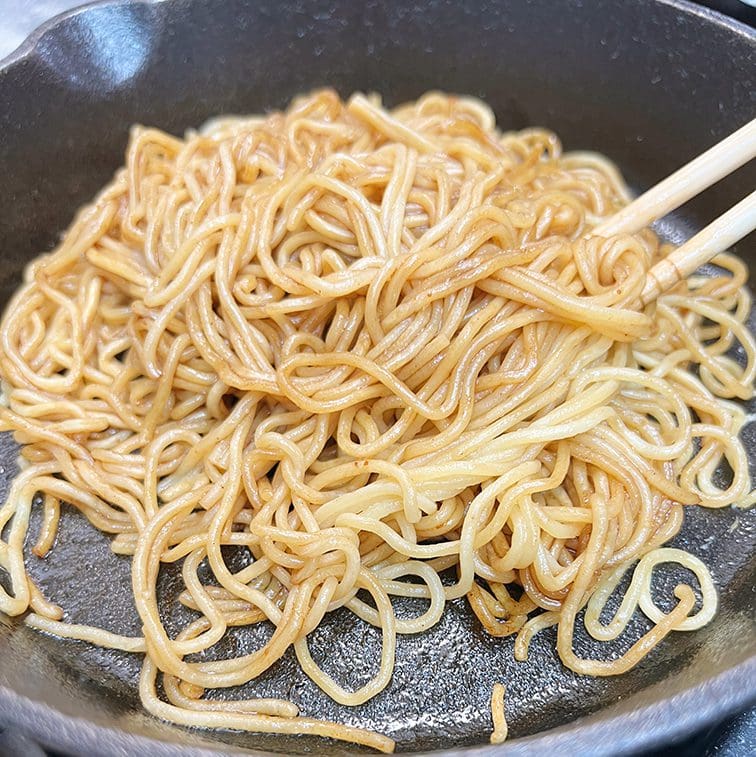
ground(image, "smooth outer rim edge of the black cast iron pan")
xmin=0 ymin=0 xmax=756 ymax=757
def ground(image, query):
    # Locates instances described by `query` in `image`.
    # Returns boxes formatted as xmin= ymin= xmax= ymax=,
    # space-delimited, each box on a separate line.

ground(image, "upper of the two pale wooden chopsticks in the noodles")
xmin=591 ymin=118 xmax=756 ymax=238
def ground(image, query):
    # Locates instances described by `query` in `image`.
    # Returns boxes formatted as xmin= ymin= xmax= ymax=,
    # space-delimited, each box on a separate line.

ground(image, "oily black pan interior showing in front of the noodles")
xmin=0 ymin=214 xmax=756 ymax=754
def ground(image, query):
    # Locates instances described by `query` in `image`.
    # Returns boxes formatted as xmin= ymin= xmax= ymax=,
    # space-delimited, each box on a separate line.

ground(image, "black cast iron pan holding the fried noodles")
xmin=0 ymin=0 xmax=756 ymax=755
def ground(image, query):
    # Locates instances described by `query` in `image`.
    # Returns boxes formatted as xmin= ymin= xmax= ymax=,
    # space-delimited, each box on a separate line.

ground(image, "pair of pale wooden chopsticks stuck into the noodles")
xmin=591 ymin=118 xmax=756 ymax=305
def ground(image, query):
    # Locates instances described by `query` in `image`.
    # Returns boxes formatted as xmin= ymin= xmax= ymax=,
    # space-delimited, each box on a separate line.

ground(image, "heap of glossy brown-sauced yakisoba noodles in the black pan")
xmin=0 ymin=91 xmax=756 ymax=751
